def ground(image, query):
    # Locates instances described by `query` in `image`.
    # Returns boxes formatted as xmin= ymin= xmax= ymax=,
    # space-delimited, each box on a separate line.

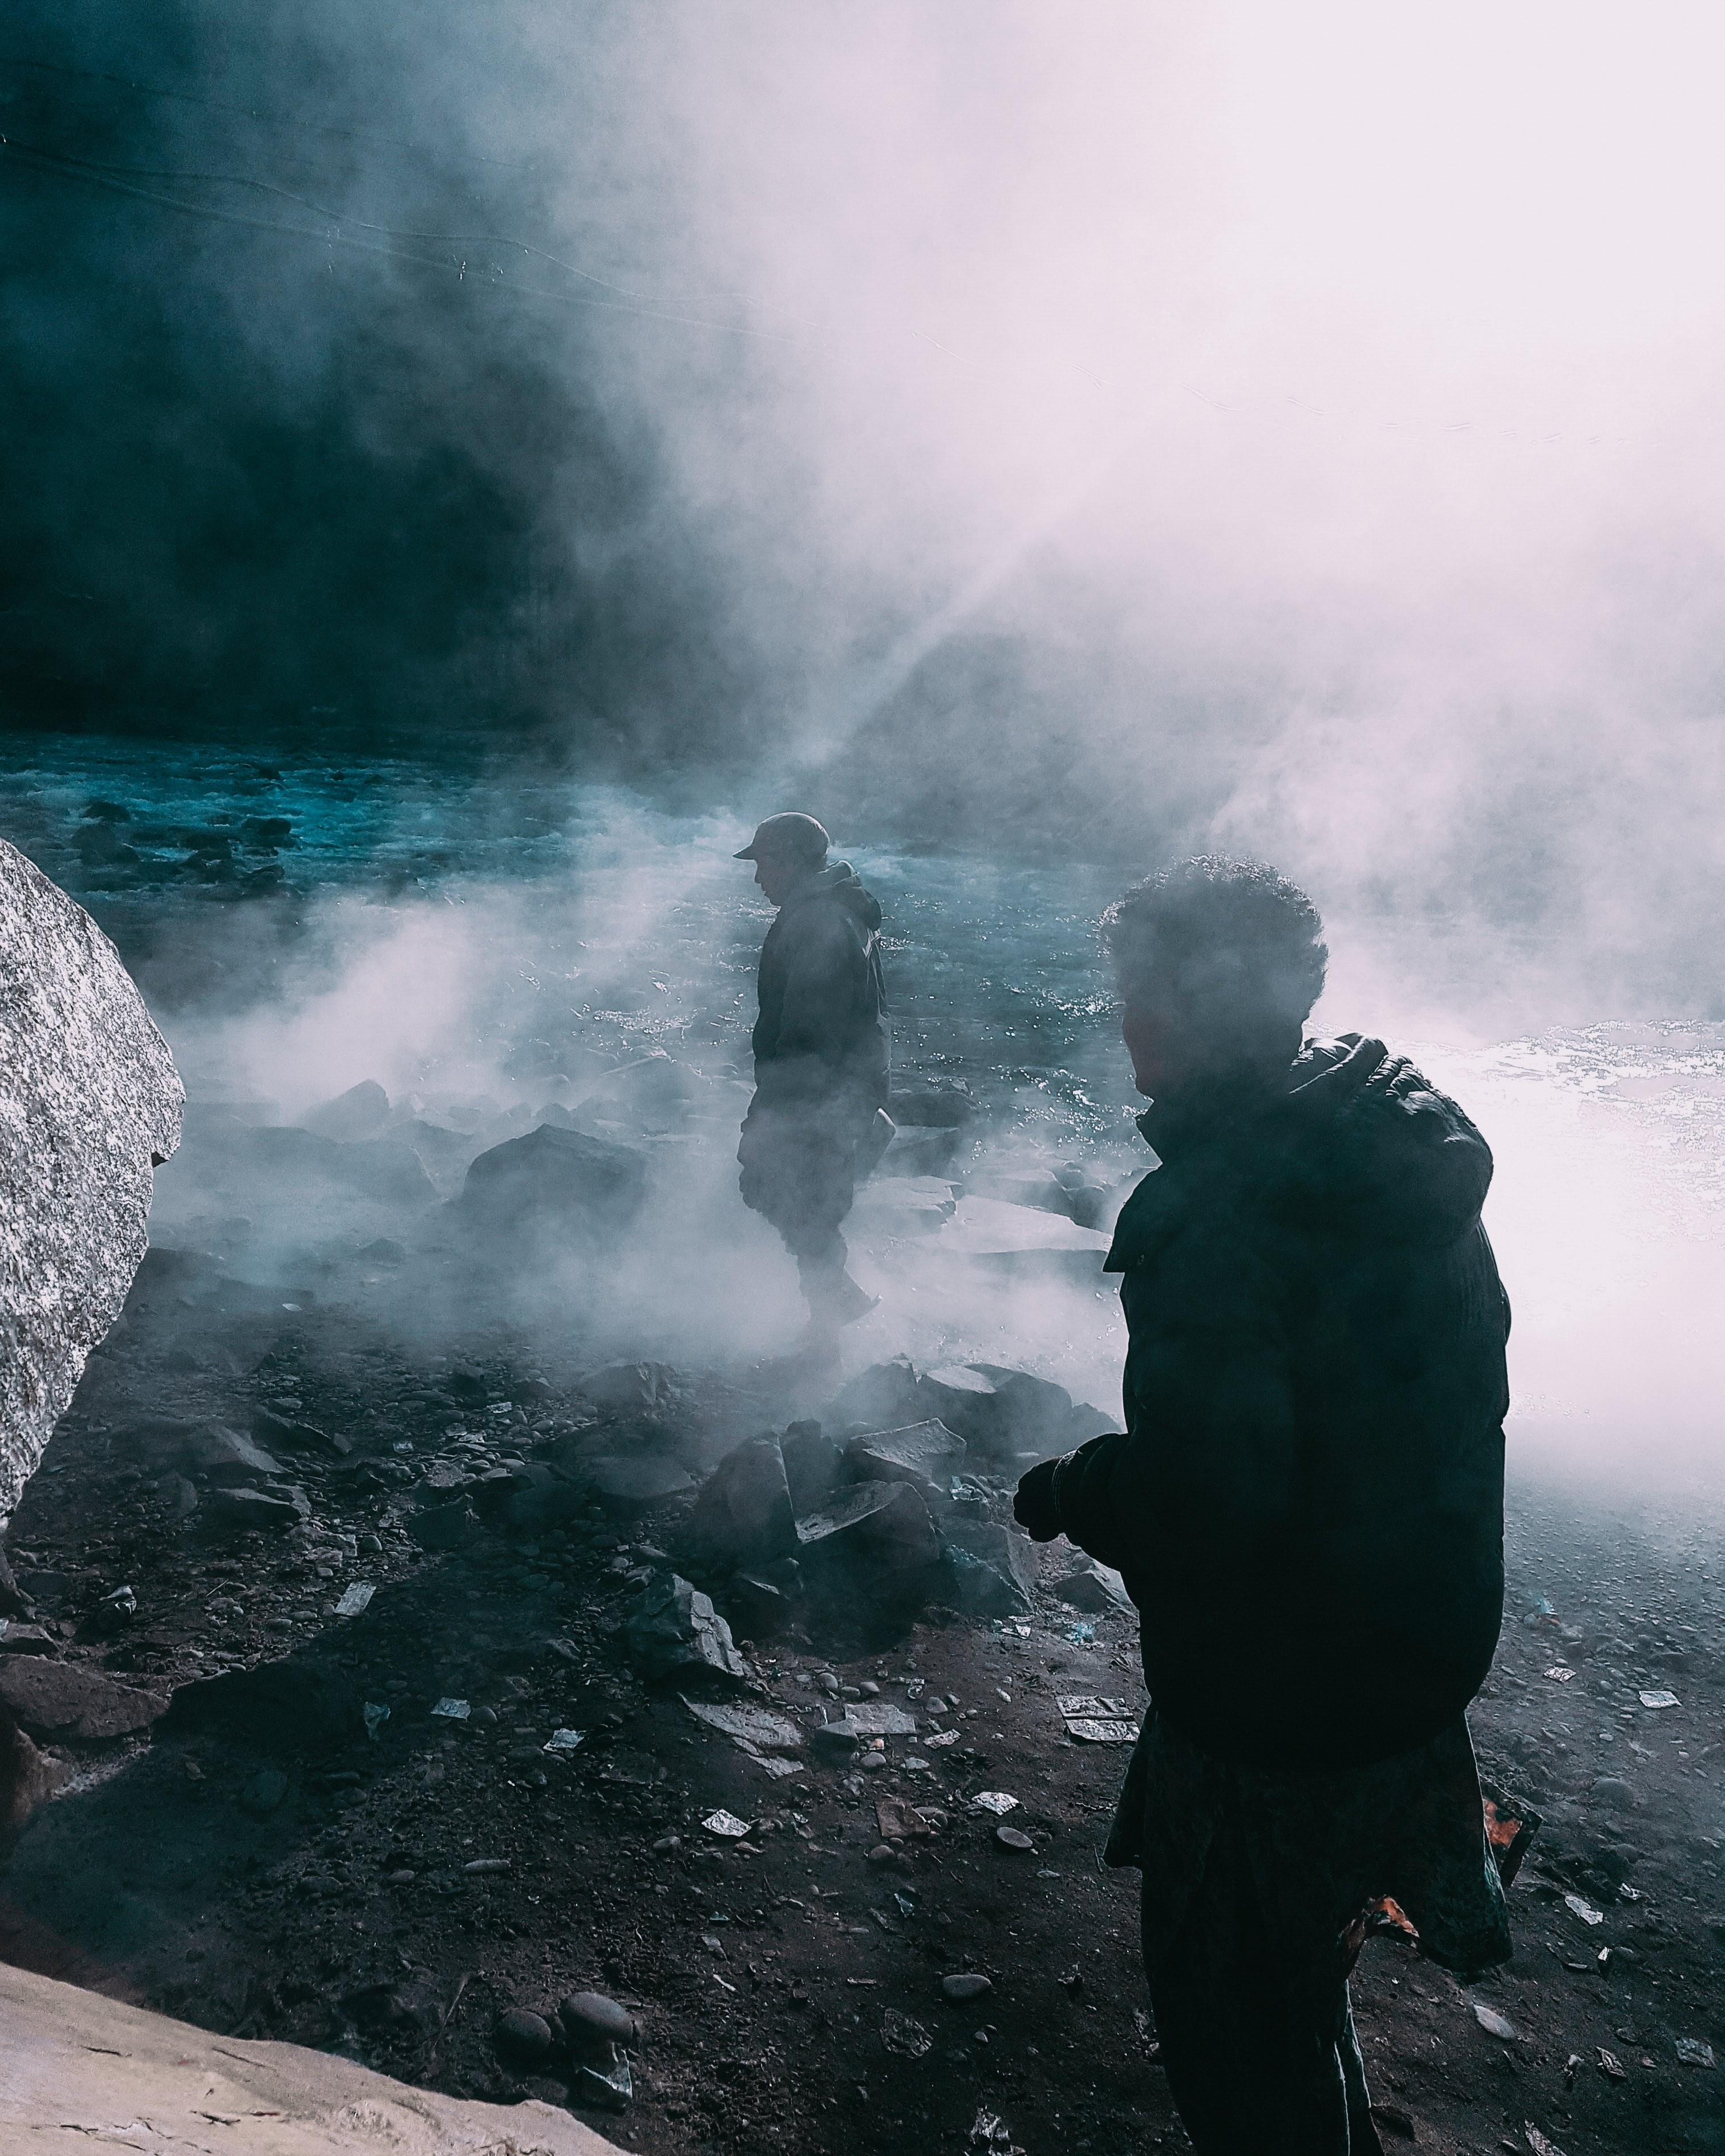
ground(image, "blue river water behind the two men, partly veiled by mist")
xmin=0 ymin=737 xmax=1725 ymax=1501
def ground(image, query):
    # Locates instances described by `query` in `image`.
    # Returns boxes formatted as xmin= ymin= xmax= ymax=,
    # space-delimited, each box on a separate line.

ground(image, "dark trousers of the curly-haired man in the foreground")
xmin=1145 ymin=1822 xmax=1382 ymax=2156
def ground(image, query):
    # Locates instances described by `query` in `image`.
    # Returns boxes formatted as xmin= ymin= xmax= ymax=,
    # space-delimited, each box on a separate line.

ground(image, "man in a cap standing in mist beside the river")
xmin=738 ymin=813 xmax=893 ymax=1337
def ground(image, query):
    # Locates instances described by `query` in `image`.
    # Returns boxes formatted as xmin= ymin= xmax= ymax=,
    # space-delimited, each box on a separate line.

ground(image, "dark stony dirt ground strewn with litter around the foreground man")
xmin=0 ymin=1279 xmax=1725 ymax=2156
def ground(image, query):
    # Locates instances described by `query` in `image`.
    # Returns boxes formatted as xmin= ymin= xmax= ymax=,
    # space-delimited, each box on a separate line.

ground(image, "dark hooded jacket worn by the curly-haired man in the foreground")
xmin=1054 ymin=1035 xmax=1509 ymax=1768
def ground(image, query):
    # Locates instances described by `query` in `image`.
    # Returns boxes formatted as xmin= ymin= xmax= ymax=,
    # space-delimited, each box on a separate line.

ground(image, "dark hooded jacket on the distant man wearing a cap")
xmin=752 ymin=860 xmax=888 ymax=1115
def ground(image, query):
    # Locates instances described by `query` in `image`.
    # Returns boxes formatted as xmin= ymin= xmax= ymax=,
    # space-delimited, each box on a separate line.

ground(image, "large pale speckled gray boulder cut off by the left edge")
xmin=0 ymin=841 xmax=185 ymax=1531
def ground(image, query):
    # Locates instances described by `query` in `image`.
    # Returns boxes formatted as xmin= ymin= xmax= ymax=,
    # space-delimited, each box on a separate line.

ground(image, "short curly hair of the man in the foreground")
xmin=1102 ymin=854 xmax=1330 ymax=1024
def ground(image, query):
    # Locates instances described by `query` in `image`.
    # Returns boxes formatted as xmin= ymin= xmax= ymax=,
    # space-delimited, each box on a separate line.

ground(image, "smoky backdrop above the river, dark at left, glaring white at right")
xmin=13 ymin=0 xmax=1725 ymax=1015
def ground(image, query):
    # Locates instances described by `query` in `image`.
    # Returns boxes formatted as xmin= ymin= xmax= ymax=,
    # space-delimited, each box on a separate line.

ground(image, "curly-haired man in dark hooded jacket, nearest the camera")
xmin=1015 ymin=858 xmax=1509 ymax=2156
